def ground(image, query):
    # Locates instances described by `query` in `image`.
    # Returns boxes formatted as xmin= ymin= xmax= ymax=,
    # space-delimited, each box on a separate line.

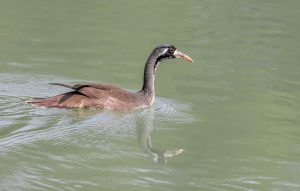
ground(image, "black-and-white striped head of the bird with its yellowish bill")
xmin=151 ymin=44 xmax=193 ymax=64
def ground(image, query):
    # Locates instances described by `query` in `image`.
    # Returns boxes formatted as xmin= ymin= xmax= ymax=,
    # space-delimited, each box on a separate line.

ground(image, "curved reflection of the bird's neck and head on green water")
xmin=137 ymin=108 xmax=183 ymax=163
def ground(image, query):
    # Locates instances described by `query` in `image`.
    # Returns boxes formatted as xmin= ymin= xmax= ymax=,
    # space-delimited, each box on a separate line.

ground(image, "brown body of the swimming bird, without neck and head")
xmin=29 ymin=83 xmax=154 ymax=111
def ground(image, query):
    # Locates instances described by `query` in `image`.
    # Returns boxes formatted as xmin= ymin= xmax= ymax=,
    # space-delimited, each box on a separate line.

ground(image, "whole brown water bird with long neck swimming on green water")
xmin=26 ymin=44 xmax=193 ymax=112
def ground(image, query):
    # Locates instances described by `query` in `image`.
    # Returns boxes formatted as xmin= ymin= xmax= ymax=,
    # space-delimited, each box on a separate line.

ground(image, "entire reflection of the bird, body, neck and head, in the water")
xmin=59 ymin=105 xmax=183 ymax=163
